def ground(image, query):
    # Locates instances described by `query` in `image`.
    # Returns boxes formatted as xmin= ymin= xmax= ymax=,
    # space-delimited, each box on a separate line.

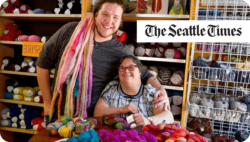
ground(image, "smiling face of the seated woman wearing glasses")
xmin=118 ymin=58 xmax=141 ymax=83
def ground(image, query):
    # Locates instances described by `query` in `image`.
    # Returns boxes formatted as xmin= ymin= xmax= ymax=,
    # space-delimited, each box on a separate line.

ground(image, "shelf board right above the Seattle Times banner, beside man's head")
xmin=86 ymin=12 xmax=189 ymax=22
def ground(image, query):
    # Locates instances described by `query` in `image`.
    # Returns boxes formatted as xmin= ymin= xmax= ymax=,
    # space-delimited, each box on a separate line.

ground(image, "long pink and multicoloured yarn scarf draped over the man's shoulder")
xmin=50 ymin=14 xmax=94 ymax=121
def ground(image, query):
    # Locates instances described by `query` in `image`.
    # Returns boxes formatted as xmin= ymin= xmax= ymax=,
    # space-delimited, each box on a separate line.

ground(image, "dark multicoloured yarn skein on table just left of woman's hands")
xmin=102 ymin=114 xmax=130 ymax=130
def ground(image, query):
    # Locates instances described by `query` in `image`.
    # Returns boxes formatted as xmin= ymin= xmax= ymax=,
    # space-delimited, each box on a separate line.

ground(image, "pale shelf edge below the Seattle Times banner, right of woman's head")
xmin=137 ymin=56 xmax=186 ymax=64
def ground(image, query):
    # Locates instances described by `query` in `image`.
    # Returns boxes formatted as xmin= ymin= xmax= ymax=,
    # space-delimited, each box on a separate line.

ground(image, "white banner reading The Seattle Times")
xmin=137 ymin=20 xmax=250 ymax=42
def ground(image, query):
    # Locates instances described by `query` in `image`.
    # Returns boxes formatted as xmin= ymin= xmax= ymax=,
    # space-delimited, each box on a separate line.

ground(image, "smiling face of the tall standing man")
xmin=95 ymin=3 xmax=123 ymax=42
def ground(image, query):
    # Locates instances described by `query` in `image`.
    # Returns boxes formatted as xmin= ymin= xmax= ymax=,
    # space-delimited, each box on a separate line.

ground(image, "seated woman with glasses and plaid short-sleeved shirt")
xmin=94 ymin=55 xmax=174 ymax=126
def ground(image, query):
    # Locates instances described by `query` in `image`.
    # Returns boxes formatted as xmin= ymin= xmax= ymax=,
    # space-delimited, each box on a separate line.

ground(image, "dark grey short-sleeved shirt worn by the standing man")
xmin=36 ymin=22 xmax=153 ymax=116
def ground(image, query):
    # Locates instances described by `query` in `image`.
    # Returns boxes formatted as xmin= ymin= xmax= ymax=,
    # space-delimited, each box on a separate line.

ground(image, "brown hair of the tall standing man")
xmin=93 ymin=0 xmax=125 ymax=28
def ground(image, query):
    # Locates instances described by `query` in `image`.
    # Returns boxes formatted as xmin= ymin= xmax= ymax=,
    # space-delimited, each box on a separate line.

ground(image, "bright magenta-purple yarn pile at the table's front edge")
xmin=99 ymin=129 xmax=157 ymax=142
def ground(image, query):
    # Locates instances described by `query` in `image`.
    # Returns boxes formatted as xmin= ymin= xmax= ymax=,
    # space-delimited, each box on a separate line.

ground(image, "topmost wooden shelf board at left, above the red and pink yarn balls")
xmin=0 ymin=14 xmax=81 ymax=22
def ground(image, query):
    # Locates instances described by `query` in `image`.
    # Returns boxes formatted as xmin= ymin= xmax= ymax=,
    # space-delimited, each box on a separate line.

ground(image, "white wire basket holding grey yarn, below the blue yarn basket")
xmin=188 ymin=102 xmax=250 ymax=125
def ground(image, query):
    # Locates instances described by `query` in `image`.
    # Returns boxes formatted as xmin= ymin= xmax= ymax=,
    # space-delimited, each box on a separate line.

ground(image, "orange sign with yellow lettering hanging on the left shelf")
xmin=22 ymin=42 xmax=44 ymax=57
